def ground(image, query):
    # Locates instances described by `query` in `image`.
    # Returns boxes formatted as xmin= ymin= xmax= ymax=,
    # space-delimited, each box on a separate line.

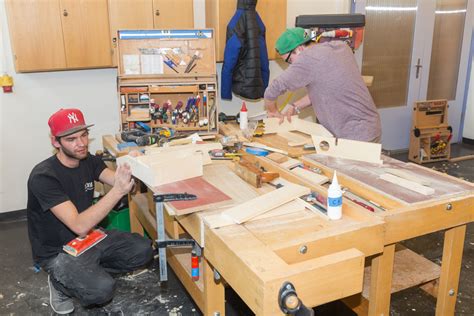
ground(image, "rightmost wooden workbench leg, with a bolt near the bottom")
xmin=436 ymin=225 xmax=466 ymax=316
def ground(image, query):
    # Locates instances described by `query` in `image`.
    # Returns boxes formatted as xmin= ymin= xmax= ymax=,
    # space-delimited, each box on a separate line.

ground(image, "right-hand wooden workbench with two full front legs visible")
xmin=278 ymin=155 xmax=474 ymax=315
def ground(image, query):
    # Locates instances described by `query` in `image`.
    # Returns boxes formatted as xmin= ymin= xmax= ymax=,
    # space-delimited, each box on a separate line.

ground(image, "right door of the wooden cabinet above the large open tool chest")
xmin=153 ymin=0 xmax=194 ymax=29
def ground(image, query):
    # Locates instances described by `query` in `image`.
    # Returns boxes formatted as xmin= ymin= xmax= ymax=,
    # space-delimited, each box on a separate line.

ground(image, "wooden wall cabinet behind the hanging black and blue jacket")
xmin=206 ymin=0 xmax=287 ymax=61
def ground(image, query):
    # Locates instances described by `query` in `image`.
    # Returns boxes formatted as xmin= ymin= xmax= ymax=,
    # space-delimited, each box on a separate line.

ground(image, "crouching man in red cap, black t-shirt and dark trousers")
xmin=27 ymin=109 xmax=153 ymax=314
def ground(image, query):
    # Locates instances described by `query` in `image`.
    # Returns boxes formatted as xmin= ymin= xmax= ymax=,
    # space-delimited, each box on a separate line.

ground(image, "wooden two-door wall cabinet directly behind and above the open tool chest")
xmin=109 ymin=0 xmax=194 ymax=67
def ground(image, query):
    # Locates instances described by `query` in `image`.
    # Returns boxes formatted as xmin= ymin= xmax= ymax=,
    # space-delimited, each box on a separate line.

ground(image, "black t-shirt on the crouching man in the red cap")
xmin=27 ymin=154 xmax=106 ymax=262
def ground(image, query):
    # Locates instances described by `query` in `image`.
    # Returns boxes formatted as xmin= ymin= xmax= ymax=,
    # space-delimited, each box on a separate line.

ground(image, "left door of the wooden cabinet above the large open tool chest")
xmin=109 ymin=0 xmax=153 ymax=67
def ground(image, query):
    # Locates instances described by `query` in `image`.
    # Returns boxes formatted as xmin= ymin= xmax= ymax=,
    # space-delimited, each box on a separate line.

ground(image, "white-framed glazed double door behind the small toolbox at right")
xmin=354 ymin=0 xmax=474 ymax=150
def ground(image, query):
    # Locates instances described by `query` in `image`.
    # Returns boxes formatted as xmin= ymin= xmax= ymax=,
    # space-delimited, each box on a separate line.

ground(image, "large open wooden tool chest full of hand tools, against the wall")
xmin=117 ymin=29 xmax=218 ymax=134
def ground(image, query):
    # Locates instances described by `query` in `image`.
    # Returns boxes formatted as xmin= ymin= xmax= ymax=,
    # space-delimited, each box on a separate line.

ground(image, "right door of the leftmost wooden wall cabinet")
xmin=60 ymin=0 xmax=112 ymax=68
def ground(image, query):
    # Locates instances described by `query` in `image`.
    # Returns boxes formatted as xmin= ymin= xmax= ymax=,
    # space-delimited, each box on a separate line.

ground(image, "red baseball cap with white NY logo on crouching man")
xmin=48 ymin=109 xmax=94 ymax=137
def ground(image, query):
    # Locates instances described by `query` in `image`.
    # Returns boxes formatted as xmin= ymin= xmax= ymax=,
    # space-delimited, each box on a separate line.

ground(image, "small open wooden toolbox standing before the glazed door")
xmin=408 ymin=100 xmax=452 ymax=163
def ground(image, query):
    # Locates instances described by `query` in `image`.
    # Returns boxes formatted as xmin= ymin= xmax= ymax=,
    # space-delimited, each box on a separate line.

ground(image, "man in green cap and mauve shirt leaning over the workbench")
xmin=264 ymin=27 xmax=381 ymax=143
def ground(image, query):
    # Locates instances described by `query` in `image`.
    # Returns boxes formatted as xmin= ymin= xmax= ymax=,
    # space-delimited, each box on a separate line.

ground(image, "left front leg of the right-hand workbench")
xmin=369 ymin=244 xmax=395 ymax=316
